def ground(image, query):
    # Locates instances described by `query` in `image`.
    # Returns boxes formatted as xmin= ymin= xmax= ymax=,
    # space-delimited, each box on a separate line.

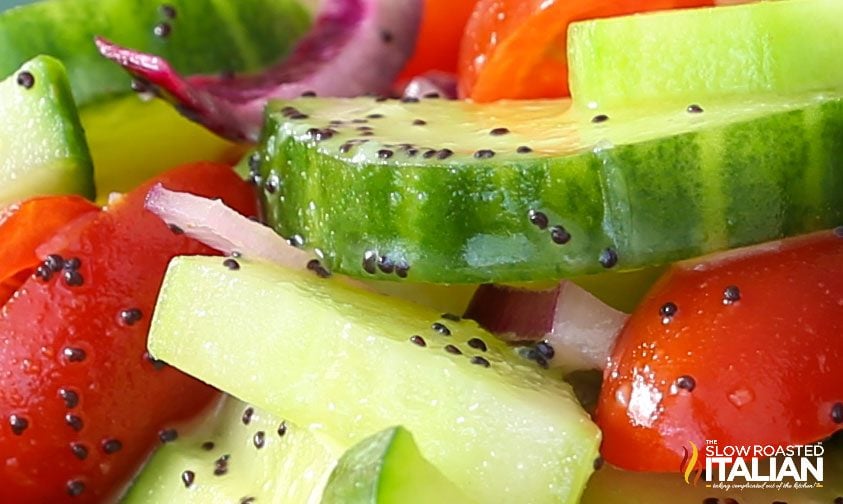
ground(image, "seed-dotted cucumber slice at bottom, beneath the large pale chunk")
xmin=122 ymin=398 xmax=342 ymax=504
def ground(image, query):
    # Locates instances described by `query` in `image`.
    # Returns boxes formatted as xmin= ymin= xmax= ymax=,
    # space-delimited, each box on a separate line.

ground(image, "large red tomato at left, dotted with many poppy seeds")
xmin=0 ymin=164 xmax=255 ymax=503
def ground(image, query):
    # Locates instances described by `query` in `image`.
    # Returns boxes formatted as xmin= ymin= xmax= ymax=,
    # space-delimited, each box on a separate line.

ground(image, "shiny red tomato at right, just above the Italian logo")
xmin=597 ymin=231 xmax=843 ymax=471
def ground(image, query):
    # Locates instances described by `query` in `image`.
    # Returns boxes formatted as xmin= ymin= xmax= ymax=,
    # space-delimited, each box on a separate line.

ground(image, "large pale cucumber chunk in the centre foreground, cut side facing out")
xmin=149 ymin=257 xmax=600 ymax=503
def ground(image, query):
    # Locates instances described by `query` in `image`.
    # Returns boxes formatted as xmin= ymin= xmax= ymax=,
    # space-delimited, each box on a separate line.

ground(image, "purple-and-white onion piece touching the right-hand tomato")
xmin=466 ymin=281 xmax=628 ymax=371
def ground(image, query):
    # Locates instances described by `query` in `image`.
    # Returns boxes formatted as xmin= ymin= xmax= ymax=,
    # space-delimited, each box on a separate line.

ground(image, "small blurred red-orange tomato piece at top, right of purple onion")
xmin=398 ymin=0 xmax=477 ymax=81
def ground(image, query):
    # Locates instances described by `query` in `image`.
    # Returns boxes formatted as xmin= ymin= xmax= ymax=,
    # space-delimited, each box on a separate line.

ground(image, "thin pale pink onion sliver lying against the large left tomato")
xmin=145 ymin=184 xmax=313 ymax=269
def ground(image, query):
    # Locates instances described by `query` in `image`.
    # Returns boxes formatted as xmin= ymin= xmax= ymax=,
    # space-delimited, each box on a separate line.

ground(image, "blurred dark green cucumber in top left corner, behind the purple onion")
xmin=0 ymin=0 xmax=310 ymax=107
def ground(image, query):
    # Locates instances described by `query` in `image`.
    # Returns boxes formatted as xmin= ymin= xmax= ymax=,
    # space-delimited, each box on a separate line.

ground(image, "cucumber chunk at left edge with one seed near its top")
xmin=0 ymin=56 xmax=94 ymax=206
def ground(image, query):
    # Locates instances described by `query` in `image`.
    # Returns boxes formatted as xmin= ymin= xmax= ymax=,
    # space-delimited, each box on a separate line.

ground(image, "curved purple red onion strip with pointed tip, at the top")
xmin=97 ymin=0 xmax=422 ymax=141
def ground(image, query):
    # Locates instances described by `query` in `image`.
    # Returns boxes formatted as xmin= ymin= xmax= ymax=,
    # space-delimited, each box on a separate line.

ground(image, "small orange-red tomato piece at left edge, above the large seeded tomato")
xmin=0 ymin=196 xmax=99 ymax=305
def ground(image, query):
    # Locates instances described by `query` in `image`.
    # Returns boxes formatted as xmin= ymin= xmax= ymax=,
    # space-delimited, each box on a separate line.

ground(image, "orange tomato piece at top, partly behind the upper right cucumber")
xmin=459 ymin=0 xmax=713 ymax=102
